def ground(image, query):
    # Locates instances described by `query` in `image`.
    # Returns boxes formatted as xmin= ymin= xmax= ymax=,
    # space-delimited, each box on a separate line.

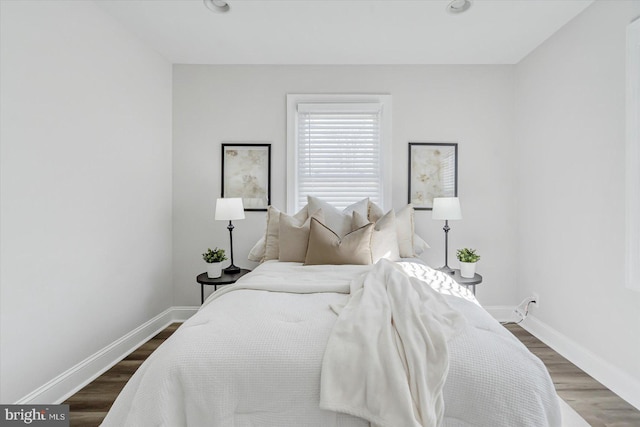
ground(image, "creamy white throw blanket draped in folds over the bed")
xmin=320 ymin=259 xmax=464 ymax=427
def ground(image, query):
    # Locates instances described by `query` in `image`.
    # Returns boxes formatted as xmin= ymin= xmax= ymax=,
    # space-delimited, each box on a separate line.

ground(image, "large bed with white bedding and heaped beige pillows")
xmin=102 ymin=200 xmax=561 ymax=427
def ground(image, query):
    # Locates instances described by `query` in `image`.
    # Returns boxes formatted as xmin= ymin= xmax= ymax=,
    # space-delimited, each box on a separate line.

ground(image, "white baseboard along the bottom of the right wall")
xmin=520 ymin=315 xmax=640 ymax=409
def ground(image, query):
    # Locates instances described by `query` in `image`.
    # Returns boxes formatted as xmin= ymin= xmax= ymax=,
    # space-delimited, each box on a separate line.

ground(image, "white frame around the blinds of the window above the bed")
xmin=287 ymin=94 xmax=392 ymax=213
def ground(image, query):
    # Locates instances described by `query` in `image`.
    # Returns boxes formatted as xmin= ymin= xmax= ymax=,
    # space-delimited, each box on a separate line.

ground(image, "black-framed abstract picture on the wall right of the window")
xmin=409 ymin=142 xmax=458 ymax=210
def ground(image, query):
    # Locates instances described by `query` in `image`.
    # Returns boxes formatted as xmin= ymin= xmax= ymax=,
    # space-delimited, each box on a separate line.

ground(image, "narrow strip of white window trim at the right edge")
xmin=625 ymin=19 xmax=640 ymax=291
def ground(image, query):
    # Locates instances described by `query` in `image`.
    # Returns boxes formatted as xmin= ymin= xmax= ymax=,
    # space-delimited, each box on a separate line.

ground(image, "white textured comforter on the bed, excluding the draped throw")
xmin=103 ymin=262 xmax=560 ymax=427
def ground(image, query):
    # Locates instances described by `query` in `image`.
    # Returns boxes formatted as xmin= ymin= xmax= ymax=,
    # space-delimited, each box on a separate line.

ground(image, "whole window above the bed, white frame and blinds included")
xmin=287 ymin=95 xmax=391 ymax=212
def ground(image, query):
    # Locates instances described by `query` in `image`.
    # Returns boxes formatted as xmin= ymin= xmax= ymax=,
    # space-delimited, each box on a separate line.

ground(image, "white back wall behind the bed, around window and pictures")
xmin=173 ymin=65 xmax=516 ymax=305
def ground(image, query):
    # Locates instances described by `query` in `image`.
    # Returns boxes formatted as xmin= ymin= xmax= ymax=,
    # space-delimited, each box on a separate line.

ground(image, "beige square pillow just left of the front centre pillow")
xmin=279 ymin=209 xmax=324 ymax=262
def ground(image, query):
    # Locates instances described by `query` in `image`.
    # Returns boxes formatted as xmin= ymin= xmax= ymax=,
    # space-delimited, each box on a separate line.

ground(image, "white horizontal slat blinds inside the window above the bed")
xmin=295 ymin=103 xmax=384 ymax=209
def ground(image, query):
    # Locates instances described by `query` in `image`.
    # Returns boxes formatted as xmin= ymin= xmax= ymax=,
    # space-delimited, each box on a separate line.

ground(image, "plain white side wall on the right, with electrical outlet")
xmin=515 ymin=1 xmax=640 ymax=406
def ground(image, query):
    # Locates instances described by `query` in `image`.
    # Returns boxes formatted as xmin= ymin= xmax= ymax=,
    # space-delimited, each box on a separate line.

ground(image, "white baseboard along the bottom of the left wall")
xmin=15 ymin=307 xmax=198 ymax=404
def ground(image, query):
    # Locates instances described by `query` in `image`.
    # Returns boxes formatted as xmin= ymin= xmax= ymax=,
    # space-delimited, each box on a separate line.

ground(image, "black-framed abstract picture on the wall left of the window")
xmin=222 ymin=143 xmax=271 ymax=211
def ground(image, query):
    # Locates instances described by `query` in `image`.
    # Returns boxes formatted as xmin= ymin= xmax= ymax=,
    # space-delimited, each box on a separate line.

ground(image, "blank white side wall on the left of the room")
xmin=0 ymin=1 xmax=172 ymax=403
